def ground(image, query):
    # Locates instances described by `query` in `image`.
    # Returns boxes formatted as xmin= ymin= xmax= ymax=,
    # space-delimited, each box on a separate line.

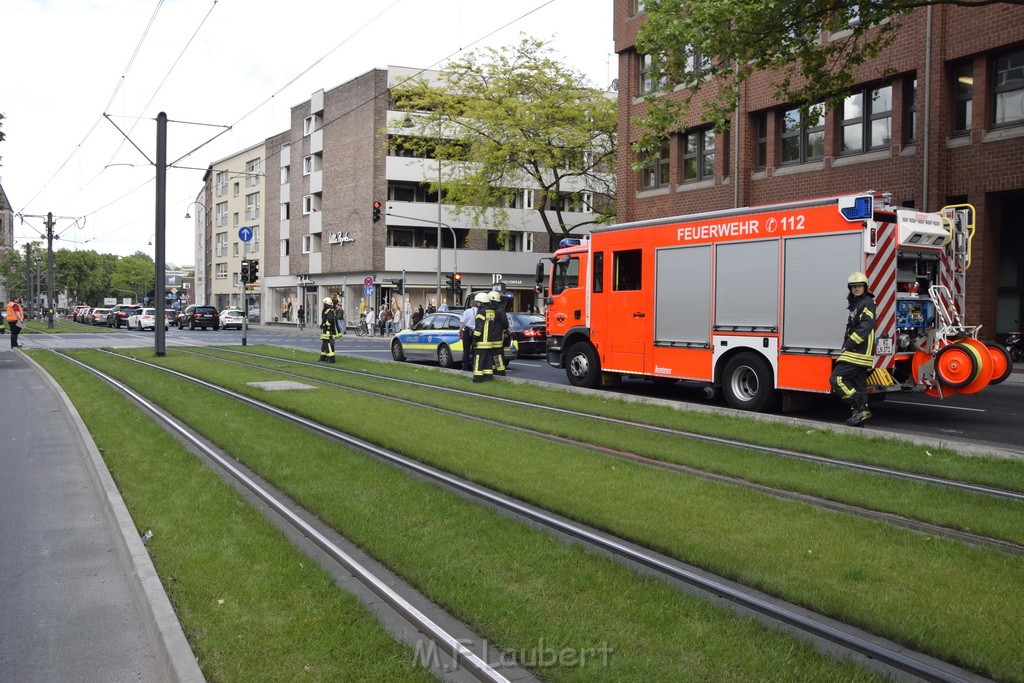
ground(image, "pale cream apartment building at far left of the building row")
xmin=200 ymin=142 xmax=266 ymax=322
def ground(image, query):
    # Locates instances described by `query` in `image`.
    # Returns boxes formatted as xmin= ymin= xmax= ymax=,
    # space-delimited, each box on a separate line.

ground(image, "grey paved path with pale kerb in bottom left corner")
xmin=0 ymin=348 xmax=204 ymax=681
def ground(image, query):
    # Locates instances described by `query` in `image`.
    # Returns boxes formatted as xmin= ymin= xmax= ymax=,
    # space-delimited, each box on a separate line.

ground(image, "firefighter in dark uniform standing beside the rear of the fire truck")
xmin=828 ymin=272 xmax=874 ymax=427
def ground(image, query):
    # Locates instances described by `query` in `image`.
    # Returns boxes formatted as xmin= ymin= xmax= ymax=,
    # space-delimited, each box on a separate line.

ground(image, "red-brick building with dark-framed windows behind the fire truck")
xmin=614 ymin=0 xmax=1024 ymax=339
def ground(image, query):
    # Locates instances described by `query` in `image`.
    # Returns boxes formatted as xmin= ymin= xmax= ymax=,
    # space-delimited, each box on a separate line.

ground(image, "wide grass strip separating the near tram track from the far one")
xmin=81 ymin=355 xmax=1024 ymax=678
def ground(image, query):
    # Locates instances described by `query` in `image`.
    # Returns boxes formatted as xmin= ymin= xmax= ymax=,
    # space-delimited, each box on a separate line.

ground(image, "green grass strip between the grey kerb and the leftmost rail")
xmin=34 ymin=353 xmax=432 ymax=681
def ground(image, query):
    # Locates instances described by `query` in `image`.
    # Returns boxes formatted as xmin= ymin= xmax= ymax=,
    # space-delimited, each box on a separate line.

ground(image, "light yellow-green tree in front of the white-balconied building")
xmin=389 ymin=38 xmax=617 ymax=243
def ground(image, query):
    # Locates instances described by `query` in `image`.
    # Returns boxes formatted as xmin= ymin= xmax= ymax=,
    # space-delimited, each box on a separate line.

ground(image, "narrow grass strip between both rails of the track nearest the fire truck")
xmin=176 ymin=349 xmax=1024 ymax=543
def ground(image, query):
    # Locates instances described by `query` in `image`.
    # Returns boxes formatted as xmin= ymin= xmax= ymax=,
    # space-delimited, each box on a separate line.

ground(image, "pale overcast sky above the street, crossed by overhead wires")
xmin=0 ymin=0 xmax=617 ymax=266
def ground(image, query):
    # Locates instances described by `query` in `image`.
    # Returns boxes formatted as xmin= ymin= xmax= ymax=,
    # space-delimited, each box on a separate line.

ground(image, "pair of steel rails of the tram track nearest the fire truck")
xmin=157 ymin=349 xmax=1024 ymax=555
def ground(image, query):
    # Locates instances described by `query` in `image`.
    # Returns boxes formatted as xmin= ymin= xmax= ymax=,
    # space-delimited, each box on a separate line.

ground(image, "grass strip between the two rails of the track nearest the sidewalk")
xmin=44 ymin=352 xmax=870 ymax=681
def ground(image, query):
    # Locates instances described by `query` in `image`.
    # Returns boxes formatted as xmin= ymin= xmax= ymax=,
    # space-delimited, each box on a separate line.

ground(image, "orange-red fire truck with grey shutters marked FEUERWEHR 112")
xmin=537 ymin=190 xmax=1013 ymax=412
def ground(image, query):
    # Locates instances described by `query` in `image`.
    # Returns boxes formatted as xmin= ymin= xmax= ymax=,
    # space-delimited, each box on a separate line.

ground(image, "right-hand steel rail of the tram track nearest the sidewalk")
xmin=66 ymin=351 xmax=980 ymax=681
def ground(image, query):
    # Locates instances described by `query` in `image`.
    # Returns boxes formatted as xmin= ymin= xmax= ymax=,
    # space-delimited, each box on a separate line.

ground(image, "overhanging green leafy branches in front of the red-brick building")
xmin=633 ymin=0 xmax=1024 ymax=157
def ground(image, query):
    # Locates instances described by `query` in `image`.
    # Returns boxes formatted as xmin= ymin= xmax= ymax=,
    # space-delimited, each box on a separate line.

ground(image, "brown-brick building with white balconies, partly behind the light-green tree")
xmin=262 ymin=67 xmax=606 ymax=326
